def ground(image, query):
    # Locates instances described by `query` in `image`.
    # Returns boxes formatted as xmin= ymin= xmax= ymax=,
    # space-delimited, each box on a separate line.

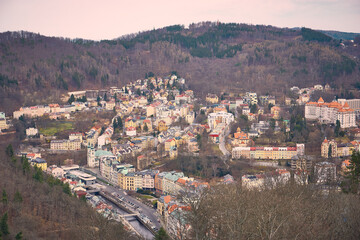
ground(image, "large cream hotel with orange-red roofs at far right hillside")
xmin=305 ymin=98 xmax=356 ymax=128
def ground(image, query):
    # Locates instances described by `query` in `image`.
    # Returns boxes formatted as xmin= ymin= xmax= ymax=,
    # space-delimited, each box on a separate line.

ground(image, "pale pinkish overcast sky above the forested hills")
xmin=0 ymin=0 xmax=360 ymax=40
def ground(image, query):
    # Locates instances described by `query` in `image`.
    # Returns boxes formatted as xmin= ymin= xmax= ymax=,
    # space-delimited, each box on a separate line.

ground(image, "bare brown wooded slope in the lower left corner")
xmin=0 ymin=139 xmax=134 ymax=240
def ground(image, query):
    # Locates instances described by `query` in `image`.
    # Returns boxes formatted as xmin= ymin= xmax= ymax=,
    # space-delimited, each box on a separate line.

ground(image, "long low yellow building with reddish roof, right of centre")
xmin=232 ymin=144 xmax=304 ymax=160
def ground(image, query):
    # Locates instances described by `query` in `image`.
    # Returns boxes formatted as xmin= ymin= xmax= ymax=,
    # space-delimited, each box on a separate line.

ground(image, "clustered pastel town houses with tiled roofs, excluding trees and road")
xmin=7 ymin=75 xmax=360 ymax=240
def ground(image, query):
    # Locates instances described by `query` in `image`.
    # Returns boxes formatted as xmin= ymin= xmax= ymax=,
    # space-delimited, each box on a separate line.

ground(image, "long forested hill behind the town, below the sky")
xmin=0 ymin=22 xmax=360 ymax=112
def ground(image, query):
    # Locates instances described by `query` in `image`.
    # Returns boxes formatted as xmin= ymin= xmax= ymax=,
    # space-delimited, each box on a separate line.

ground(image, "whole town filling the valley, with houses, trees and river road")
xmin=0 ymin=71 xmax=360 ymax=239
